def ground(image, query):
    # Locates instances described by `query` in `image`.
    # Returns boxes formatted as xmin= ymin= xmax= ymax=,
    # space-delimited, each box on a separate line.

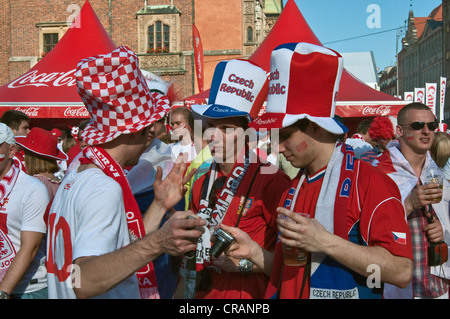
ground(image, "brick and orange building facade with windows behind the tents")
xmin=0 ymin=0 xmax=283 ymax=97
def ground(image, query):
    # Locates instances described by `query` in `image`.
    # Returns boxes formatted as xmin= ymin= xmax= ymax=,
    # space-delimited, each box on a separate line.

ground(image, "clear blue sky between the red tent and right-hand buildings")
xmin=283 ymin=0 xmax=442 ymax=70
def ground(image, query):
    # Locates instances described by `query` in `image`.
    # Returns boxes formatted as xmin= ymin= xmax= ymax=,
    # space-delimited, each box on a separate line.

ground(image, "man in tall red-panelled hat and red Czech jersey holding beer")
xmin=230 ymin=43 xmax=412 ymax=299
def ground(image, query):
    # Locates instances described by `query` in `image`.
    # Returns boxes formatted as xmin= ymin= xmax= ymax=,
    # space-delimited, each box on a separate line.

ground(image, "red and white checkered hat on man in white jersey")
xmin=75 ymin=46 xmax=170 ymax=145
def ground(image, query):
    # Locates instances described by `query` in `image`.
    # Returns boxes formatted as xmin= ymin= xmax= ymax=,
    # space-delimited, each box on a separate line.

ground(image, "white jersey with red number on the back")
xmin=47 ymin=168 xmax=140 ymax=299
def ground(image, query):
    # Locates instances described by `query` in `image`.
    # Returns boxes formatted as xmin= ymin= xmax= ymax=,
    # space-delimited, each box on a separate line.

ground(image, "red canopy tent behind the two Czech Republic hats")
xmin=184 ymin=0 xmax=407 ymax=129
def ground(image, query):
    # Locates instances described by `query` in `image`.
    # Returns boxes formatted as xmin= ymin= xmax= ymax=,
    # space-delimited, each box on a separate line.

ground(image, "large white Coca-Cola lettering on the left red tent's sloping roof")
xmin=8 ymin=69 xmax=77 ymax=89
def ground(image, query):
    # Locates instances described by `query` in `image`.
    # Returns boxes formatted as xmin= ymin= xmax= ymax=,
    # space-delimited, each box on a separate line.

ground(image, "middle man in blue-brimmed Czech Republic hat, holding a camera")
xmin=177 ymin=60 xmax=289 ymax=299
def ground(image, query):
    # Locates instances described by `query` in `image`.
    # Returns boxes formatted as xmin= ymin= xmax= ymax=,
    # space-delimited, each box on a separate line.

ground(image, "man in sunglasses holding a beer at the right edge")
xmin=373 ymin=103 xmax=450 ymax=298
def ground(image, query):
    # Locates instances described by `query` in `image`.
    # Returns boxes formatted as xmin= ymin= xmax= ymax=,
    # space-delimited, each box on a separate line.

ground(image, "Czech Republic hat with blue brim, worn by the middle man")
xmin=191 ymin=59 xmax=269 ymax=122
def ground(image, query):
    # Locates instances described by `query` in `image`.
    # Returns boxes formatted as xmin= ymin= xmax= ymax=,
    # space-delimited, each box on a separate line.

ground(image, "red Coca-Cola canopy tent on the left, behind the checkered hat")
xmin=0 ymin=1 xmax=116 ymax=129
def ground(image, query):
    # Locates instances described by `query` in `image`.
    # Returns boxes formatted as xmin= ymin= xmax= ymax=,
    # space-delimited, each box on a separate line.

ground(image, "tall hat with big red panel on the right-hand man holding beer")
xmin=250 ymin=42 xmax=348 ymax=134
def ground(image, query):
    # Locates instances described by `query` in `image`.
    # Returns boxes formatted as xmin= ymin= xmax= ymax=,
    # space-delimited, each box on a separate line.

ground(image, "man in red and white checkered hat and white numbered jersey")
xmin=47 ymin=47 xmax=204 ymax=299
